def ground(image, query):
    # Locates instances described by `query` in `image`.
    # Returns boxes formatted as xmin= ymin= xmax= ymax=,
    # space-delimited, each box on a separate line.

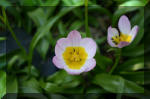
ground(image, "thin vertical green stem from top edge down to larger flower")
xmin=85 ymin=0 xmax=91 ymax=37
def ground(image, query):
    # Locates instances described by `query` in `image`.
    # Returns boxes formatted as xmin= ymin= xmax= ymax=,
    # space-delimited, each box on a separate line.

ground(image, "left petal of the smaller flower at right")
xmin=107 ymin=26 xmax=119 ymax=47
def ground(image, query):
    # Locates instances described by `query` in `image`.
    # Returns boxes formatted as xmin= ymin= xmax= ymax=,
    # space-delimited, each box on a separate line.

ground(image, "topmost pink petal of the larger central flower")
xmin=67 ymin=30 xmax=81 ymax=46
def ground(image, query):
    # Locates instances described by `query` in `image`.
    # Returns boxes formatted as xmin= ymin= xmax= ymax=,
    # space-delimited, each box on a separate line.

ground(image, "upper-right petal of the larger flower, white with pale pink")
xmin=80 ymin=38 xmax=97 ymax=59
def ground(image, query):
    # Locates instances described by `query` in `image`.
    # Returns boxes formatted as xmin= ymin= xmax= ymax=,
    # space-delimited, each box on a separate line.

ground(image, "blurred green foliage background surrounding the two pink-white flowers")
xmin=0 ymin=0 xmax=150 ymax=99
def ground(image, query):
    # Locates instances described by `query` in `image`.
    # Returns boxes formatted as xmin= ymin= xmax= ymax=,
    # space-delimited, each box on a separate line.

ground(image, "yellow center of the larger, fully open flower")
xmin=63 ymin=47 xmax=88 ymax=69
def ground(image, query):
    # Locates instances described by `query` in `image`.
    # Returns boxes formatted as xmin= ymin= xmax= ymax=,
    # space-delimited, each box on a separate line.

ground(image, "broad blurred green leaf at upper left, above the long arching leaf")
xmin=28 ymin=8 xmax=47 ymax=27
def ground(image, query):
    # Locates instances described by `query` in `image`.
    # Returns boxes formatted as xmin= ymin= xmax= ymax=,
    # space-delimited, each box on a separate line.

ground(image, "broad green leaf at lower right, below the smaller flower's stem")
xmin=93 ymin=74 xmax=144 ymax=93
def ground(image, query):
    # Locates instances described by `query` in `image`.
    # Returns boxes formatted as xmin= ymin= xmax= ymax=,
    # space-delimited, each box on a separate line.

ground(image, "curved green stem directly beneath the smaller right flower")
xmin=109 ymin=49 xmax=121 ymax=74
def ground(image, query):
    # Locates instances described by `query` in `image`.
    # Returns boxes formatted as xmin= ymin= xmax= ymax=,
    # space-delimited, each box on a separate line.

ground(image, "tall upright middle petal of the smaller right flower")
xmin=118 ymin=15 xmax=131 ymax=34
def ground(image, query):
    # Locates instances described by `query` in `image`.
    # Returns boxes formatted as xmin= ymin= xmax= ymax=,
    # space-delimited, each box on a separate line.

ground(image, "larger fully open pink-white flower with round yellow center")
xmin=53 ymin=30 xmax=96 ymax=75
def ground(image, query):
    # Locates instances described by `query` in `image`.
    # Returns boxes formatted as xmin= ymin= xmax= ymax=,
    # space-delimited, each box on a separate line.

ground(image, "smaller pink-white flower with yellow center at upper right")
xmin=107 ymin=15 xmax=138 ymax=48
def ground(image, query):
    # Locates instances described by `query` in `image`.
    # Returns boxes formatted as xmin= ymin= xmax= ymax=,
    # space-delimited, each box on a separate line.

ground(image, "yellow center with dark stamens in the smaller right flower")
xmin=112 ymin=33 xmax=131 ymax=45
